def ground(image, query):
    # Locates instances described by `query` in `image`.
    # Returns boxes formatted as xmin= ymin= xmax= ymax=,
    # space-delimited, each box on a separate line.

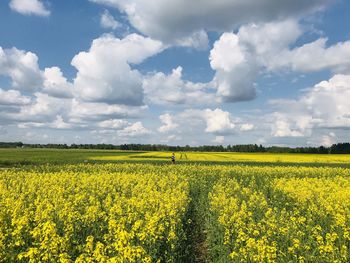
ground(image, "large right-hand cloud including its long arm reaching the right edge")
xmin=210 ymin=19 xmax=350 ymax=102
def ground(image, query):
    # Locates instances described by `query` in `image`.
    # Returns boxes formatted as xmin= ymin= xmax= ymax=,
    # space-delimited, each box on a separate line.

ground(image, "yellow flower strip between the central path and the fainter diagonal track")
xmin=209 ymin=178 xmax=277 ymax=262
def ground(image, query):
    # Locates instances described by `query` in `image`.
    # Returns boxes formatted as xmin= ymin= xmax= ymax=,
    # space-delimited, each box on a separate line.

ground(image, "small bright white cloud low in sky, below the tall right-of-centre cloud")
xmin=203 ymin=109 xmax=235 ymax=134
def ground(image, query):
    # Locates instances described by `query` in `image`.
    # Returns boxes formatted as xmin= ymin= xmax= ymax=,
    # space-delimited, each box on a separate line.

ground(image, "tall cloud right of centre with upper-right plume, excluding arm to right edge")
xmin=210 ymin=20 xmax=301 ymax=102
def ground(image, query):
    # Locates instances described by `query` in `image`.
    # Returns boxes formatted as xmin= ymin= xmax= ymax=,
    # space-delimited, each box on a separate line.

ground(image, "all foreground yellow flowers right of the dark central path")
xmin=209 ymin=167 xmax=350 ymax=262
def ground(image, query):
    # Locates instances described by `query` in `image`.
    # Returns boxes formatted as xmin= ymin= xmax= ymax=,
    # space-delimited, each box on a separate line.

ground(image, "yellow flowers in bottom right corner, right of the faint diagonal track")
xmin=275 ymin=176 xmax=350 ymax=261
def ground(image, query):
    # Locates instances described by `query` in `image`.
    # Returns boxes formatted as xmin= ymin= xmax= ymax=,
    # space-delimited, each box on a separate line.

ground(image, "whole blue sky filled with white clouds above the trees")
xmin=0 ymin=0 xmax=350 ymax=147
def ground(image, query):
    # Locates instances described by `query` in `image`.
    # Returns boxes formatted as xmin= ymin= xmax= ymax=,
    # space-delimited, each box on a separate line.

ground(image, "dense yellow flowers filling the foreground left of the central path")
xmin=0 ymin=165 xmax=189 ymax=262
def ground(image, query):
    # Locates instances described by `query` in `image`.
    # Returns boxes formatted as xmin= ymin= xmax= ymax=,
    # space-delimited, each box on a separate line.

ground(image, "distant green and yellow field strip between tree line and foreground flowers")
xmin=0 ymin=148 xmax=350 ymax=167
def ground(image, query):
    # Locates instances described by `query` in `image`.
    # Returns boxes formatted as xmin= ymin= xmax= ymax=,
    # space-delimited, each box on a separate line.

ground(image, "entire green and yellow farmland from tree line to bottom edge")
xmin=0 ymin=149 xmax=350 ymax=262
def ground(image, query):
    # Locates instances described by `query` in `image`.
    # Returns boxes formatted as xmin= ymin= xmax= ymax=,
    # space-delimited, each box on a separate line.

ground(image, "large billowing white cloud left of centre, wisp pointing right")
xmin=72 ymin=34 xmax=163 ymax=105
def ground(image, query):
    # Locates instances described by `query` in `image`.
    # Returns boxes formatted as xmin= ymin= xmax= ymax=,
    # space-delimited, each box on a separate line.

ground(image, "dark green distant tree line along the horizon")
xmin=0 ymin=142 xmax=350 ymax=154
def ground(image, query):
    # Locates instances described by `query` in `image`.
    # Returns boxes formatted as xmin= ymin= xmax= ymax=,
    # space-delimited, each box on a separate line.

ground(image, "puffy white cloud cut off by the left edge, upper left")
xmin=0 ymin=47 xmax=43 ymax=91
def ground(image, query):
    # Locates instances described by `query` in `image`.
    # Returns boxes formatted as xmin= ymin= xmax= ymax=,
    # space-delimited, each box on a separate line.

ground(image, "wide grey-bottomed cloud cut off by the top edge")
xmin=90 ymin=0 xmax=333 ymax=44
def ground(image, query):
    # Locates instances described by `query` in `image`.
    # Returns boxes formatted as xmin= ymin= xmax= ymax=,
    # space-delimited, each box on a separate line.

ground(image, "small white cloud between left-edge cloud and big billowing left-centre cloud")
xmin=43 ymin=67 xmax=73 ymax=98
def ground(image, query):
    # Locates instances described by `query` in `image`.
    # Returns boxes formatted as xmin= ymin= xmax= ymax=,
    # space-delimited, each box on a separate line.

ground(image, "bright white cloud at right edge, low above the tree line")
xmin=271 ymin=75 xmax=350 ymax=137
